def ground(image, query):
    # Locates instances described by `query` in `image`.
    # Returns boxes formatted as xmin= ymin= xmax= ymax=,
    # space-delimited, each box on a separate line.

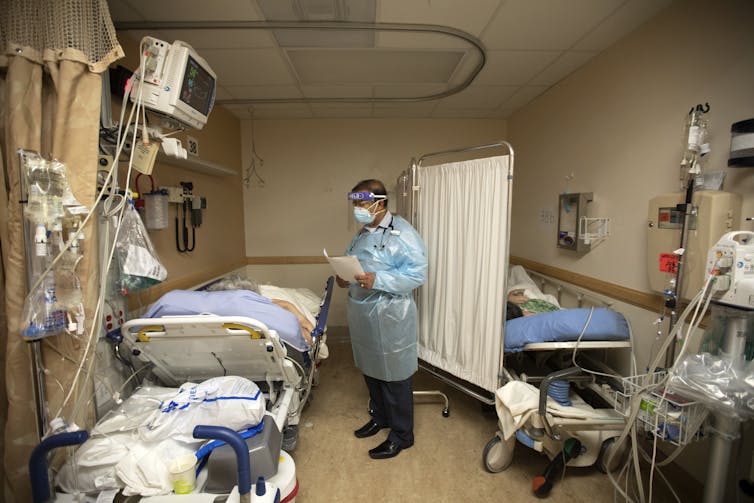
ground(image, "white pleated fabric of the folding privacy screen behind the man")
xmin=415 ymin=156 xmax=510 ymax=391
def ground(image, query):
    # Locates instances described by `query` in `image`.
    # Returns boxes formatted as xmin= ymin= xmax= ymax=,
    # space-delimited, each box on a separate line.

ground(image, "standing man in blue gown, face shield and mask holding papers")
xmin=337 ymin=180 xmax=427 ymax=459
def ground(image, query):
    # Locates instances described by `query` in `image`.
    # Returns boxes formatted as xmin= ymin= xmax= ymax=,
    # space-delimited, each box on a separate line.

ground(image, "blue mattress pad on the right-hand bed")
xmin=505 ymin=308 xmax=630 ymax=353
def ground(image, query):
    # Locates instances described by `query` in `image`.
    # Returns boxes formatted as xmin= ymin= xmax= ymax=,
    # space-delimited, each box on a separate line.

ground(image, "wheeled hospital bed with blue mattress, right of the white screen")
xmin=482 ymin=266 xmax=632 ymax=495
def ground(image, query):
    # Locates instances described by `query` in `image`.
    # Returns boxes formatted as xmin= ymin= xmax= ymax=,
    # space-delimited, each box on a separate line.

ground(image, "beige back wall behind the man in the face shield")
xmin=243 ymin=119 xmax=506 ymax=325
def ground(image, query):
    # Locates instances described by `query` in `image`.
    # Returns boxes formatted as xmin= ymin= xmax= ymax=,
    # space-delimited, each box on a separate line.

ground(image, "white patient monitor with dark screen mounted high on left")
xmin=130 ymin=37 xmax=217 ymax=129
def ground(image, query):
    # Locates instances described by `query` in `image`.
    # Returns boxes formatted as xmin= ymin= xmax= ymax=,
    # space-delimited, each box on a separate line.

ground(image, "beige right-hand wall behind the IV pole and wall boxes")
xmin=508 ymin=0 xmax=754 ymax=488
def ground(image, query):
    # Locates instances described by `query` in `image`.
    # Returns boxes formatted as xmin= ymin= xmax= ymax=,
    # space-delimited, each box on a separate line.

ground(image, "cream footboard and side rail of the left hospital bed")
xmin=121 ymin=277 xmax=334 ymax=450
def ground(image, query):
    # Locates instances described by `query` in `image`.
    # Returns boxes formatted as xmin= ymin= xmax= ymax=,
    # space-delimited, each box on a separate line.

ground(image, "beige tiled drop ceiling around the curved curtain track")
xmin=104 ymin=0 xmax=671 ymax=117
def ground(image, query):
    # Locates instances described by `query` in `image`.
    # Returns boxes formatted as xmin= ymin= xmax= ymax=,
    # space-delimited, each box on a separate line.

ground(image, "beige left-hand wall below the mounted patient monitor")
xmin=114 ymin=34 xmax=245 ymax=308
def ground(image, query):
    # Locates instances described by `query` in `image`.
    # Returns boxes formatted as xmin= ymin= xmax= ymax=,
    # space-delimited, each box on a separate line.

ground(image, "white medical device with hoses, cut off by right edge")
xmin=707 ymin=231 xmax=754 ymax=310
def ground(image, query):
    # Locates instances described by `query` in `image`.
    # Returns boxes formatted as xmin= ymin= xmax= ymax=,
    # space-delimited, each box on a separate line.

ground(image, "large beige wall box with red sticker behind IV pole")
xmin=647 ymin=190 xmax=741 ymax=299
